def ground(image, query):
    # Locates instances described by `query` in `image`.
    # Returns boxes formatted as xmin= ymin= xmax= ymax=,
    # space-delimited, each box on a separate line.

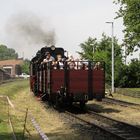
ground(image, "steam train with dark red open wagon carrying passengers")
xmin=30 ymin=46 xmax=105 ymax=107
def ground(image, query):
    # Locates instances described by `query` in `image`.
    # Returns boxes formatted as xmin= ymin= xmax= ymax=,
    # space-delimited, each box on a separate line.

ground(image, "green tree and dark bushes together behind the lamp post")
xmin=78 ymin=34 xmax=140 ymax=88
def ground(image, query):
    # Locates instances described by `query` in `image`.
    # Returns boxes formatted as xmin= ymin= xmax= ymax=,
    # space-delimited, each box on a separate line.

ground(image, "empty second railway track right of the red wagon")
xmin=103 ymin=97 xmax=140 ymax=110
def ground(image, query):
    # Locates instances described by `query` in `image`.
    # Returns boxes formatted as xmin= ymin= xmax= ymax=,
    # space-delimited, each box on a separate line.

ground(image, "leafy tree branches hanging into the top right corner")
xmin=115 ymin=0 xmax=140 ymax=54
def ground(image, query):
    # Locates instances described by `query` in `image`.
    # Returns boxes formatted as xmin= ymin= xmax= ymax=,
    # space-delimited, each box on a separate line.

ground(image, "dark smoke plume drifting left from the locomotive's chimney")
xmin=6 ymin=12 xmax=56 ymax=45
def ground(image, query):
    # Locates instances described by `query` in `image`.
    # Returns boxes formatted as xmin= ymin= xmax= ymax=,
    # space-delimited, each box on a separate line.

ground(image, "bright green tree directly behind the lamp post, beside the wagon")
xmin=78 ymin=34 xmax=123 ymax=86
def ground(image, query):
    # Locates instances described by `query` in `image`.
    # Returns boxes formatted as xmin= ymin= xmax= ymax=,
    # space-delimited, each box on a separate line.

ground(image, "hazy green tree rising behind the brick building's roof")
xmin=0 ymin=45 xmax=18 ymax=60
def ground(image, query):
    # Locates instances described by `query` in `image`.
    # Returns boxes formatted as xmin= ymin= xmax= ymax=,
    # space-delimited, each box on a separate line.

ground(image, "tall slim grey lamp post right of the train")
xmin=106 ymin=22 xmax=114 ymax=93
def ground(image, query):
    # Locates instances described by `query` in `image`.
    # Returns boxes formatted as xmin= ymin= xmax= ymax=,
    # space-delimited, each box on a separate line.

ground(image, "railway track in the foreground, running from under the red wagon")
xmin=65 ymin=106 xmax=140 ymax=140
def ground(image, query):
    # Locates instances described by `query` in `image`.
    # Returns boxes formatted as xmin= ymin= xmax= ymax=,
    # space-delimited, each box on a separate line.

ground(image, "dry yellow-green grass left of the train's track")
xmin=0 ymin=80 xmax=83 ymax=140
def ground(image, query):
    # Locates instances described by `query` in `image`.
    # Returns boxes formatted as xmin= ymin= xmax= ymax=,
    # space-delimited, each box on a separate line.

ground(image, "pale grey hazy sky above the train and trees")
xmin=0 ymin=0 xmax=139 ymax=59
